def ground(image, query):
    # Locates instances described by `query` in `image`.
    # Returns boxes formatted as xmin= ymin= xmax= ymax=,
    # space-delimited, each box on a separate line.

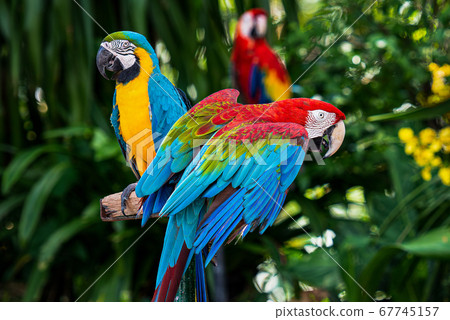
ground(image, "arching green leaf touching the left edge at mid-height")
xmin=2 ymin=145 xmax=61 ymax=194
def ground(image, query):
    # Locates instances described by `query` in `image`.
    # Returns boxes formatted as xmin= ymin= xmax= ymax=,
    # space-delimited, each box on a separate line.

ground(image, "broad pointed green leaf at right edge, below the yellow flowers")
xmin=399 ymin=227 xmax=450 ymax=259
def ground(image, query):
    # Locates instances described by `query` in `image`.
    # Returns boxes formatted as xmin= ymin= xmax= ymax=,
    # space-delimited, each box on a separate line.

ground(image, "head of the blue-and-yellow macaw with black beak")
xmin=96 ymin=31 xmax=159 ymax=83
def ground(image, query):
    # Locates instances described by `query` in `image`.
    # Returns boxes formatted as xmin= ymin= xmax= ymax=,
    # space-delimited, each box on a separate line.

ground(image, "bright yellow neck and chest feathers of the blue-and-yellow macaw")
xmin=116 ymin=48 xmax=155 ymax=175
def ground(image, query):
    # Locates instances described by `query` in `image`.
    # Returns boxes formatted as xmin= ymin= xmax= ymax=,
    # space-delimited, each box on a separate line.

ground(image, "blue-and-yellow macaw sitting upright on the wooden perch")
xmin=96 ymin=31 xmax=191 ymax=214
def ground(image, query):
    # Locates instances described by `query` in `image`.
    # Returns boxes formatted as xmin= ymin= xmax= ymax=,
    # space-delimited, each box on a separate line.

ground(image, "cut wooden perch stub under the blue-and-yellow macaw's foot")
xmin=100 ymin=191 xmax=158 ymax=221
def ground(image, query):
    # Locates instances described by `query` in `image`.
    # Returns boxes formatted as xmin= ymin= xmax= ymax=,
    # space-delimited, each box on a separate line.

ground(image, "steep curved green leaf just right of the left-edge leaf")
xmin=19 ymin=163 xmax=68 ymax=245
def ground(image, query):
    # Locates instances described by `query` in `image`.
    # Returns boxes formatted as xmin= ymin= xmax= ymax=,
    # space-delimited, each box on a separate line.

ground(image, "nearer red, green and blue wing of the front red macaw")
xmin=161 ymin=123 xmax=308 ymax=264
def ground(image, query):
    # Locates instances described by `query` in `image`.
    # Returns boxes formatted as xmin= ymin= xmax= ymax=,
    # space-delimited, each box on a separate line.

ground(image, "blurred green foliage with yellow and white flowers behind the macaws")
xmin=0 ymin=0 xmax=450 ymax=301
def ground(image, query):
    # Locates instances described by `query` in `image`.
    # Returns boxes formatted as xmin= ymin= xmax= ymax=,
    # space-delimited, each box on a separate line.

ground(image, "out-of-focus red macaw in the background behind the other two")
xmin=231 ymin=9 xmax=292 ymax=103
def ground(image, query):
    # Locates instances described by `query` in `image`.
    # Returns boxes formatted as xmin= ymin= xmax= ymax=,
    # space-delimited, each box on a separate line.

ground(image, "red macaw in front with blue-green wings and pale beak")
xmin=136 ymin=89 xmax=345 ymax=301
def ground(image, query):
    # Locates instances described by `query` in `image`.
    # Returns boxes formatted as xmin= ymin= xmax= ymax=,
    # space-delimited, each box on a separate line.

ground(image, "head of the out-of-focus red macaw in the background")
xmin=237 ymin=9 xmax=267 ymax=39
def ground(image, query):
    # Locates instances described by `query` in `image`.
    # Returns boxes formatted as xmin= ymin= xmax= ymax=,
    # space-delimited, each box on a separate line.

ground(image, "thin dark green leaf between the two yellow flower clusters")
xmin=367 ymin=100 xmax=450 ymax=122
